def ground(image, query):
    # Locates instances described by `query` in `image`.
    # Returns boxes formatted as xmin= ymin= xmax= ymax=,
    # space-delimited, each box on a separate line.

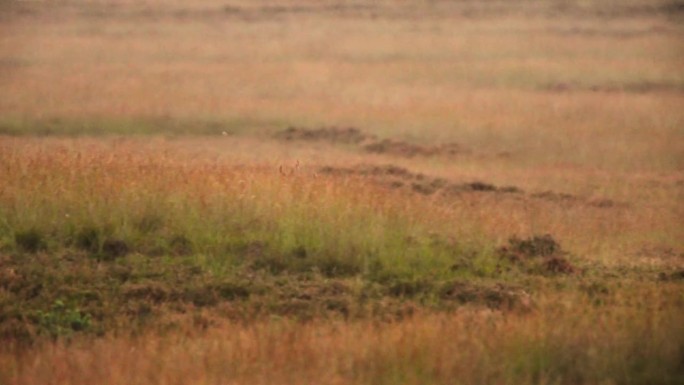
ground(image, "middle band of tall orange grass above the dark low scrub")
xmin=0 ymin=138 xmax=683 ymax=265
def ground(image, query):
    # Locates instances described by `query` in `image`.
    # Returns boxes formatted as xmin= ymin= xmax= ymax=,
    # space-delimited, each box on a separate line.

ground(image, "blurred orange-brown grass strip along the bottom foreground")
xmin=0 ymin=285 xmax=684 ymax=385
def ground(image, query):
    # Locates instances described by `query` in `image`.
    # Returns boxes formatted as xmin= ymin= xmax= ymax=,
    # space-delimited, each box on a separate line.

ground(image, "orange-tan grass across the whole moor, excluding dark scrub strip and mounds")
xmin=0 ymin=0 xmax=684 ymax=384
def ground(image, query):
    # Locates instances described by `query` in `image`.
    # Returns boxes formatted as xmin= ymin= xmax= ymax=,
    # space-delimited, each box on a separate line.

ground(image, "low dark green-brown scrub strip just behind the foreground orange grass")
xmin=0 ymin=236 xmax=530 ymax=341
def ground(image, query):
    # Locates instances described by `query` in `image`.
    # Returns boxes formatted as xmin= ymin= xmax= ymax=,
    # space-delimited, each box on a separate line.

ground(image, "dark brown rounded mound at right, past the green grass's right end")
xmin=497 ymin=234 xmax=577 ymax=274
